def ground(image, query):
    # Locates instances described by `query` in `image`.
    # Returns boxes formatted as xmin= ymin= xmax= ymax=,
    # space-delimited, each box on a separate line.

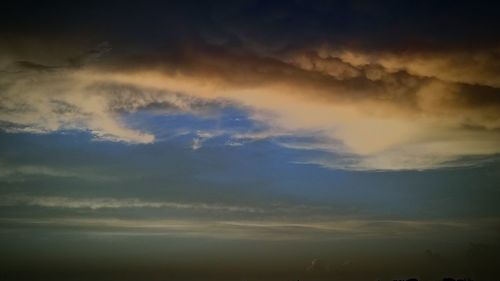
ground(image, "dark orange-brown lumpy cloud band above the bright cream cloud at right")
xmin=65 ymin=41 xmax=500 ymax=127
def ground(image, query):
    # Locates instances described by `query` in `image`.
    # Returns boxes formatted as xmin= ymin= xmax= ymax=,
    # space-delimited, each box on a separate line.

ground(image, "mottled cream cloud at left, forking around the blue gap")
xmin=0 ymin=59 xmax=229 ymax=143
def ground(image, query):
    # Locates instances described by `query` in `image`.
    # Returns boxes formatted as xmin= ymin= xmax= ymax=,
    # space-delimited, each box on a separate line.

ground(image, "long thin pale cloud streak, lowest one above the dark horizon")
xmin=0 ymin=214 xmax=496 ymax=241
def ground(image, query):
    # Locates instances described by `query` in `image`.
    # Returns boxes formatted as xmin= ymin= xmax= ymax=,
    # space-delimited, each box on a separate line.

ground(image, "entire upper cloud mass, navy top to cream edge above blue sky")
xmin=0 ymin=2 xmax=500 ymax=170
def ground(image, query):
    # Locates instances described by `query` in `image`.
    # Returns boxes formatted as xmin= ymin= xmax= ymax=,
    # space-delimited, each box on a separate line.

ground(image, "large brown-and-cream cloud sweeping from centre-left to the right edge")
xmin=100 ymin=44 xmax=500 ymax=170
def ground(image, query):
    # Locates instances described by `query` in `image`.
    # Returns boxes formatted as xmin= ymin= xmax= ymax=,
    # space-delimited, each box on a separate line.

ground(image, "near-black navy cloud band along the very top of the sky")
xmin=1 ymin=1 xmax=500 ymax=52
